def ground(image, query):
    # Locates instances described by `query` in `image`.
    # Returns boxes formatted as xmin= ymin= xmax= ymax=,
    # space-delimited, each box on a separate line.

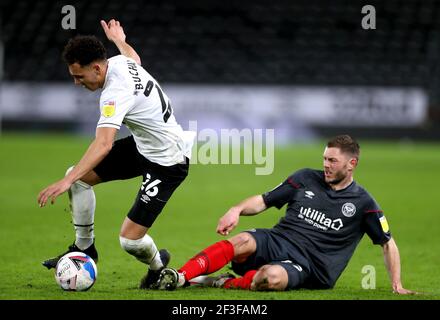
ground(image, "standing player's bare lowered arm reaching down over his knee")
xmin=38 ymin=127 xmax=117 ymax=207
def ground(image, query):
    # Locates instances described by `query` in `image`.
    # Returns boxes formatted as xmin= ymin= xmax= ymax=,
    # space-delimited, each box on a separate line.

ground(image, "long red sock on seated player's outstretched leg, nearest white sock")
xmin=178 ymin=240 xmax=234 ymax=281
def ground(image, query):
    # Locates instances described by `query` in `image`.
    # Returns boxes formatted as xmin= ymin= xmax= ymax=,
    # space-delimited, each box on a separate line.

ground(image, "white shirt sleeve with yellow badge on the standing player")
xmin=97 ymin=88 xmax=134 ymax=129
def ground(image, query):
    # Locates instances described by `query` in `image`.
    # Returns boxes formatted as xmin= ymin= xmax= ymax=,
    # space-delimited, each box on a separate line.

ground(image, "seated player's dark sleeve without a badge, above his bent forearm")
xmin=262 ymin=173 xmax=301 ymax=209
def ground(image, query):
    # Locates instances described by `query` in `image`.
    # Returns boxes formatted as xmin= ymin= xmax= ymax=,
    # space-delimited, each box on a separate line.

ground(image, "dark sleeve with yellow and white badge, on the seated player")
xmin=363 ymin=201 xmax=391 ymax=245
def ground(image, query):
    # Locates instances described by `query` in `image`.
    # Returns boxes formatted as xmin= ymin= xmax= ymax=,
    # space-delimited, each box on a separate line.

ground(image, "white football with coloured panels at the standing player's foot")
xmin=55 ymin=252 xmax=98 ymax=291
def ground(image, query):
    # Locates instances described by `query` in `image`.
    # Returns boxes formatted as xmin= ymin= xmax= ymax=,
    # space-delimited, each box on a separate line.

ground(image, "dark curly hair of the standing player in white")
xmin=63 ymin=35 xmax=107 ymax=66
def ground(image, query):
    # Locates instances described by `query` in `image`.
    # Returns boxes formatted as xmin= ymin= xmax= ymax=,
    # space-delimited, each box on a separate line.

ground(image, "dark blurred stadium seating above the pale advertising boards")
xmin=1 ymin=0 xmax=440 ymax=138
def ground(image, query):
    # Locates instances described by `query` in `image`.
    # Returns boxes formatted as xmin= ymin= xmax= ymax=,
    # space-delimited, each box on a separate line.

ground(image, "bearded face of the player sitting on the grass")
xmin=324 ymin=147 xmax=354 ymax=185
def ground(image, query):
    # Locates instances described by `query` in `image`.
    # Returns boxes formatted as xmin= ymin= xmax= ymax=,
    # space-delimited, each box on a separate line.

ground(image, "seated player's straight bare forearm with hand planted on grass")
xmin=382 ymin=238 xmax=416 ymax=294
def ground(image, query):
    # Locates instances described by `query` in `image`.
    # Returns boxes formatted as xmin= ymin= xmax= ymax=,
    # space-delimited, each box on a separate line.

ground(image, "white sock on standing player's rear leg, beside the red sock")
xmin=119 ymin=234 xmax=163 ymax=270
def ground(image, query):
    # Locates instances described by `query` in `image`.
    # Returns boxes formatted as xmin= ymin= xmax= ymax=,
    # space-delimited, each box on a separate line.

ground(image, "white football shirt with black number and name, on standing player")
xmin=97 ymin=55 xmax=195 ymax=166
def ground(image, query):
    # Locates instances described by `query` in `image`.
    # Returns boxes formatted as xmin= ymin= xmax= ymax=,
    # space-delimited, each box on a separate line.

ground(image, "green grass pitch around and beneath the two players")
xmin=0 ymin=134 xmax=440 ymax=300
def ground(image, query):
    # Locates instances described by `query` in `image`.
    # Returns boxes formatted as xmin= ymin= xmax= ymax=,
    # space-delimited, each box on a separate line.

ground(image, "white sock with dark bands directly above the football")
xmin=66 ymin=167 xmax=96 ymax=250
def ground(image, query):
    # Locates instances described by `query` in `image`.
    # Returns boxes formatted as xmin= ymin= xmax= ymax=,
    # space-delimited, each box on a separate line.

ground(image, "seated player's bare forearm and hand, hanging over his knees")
xmin=217 ymin=195 xmax=267 ymax=236
